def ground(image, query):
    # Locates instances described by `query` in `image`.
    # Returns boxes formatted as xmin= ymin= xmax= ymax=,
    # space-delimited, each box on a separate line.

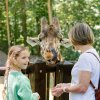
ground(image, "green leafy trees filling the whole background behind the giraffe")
xmin=0 ymin=0 xmax=100 ymax=60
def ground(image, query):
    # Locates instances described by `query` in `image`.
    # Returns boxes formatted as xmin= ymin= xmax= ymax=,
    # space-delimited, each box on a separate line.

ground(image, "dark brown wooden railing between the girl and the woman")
xmin=0 ymin=61 xmax=73 ymax=100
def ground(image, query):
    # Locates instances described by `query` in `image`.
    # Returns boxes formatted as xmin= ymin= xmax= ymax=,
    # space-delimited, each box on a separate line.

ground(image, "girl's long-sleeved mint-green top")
xmin=7 ymin=71 xmax=38 ymax=100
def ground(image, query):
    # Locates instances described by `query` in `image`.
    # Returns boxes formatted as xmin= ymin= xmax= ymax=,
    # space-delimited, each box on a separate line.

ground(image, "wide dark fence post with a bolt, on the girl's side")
xmin=34 ymin=63 xmax=46 ymax=100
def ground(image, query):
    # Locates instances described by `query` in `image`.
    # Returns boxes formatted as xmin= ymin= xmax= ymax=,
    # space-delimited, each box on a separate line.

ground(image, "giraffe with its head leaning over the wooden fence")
xmin=27 ymin=17 xmax=71 ymax=65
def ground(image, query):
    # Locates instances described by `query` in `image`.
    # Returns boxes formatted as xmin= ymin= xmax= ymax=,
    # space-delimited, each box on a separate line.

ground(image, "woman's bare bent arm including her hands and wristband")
xmin=52 ymin=71 xmax=91 ymax=97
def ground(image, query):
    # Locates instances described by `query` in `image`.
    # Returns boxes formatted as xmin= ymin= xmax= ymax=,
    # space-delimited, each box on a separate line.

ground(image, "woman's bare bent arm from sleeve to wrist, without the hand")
xmin=65 ymin=71 xmax=91 ymax=93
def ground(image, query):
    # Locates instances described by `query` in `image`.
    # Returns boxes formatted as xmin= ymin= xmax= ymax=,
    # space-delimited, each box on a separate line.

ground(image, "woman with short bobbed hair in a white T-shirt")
xmin=52 ymin=23 xmax=100 ymax=100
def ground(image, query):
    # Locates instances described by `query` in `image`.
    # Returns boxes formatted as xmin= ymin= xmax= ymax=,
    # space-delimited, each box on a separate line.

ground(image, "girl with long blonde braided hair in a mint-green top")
xmin=2 ymin=45 xmax=39 ymax=100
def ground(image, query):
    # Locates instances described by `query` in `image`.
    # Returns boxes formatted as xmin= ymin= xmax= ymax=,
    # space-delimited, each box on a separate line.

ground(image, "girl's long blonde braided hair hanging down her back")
xmin=5 ymin=45 xmax=27 ymax=88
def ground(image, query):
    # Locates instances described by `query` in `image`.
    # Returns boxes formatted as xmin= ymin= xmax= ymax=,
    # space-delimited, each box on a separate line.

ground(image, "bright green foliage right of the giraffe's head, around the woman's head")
xmin=53 ymin=0 xmax=100 ymax=60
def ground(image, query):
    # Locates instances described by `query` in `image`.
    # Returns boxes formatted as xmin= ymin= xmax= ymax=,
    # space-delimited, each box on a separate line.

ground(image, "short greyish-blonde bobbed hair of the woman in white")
xmin=68 ymin=23 xmax=94 ymax=45
